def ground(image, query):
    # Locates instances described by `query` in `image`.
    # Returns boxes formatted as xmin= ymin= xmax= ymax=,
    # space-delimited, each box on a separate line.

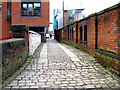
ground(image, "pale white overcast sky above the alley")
xmin=50 ymin=0 xmax=120 ymax=29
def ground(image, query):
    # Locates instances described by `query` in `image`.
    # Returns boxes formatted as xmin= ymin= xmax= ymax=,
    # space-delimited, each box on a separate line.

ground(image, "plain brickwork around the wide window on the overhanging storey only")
xmin=12 ymin=2 xmax=49 ymax=26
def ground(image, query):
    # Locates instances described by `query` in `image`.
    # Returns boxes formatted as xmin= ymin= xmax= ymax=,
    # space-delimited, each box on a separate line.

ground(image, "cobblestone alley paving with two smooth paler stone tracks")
xmin=5 ymin=40 xmax=119 ymax=90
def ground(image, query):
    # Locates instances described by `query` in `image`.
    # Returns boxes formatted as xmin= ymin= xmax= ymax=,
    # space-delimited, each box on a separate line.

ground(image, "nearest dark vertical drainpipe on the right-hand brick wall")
xmin=95 ymin=13 xmax=98 ymax=49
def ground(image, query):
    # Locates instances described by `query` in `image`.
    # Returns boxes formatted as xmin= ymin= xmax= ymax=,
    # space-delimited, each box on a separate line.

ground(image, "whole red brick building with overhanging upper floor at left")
xmin=0 ymin=0 xmax=49 ymax=41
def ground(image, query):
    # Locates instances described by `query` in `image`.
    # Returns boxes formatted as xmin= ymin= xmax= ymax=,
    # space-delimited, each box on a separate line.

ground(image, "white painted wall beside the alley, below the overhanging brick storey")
xmin=29 ymin=31 xmax=41 ymax=56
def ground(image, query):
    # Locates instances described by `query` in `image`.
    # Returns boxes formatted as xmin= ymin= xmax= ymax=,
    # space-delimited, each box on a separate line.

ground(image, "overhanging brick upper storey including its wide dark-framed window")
xmin=12 ymin=2 xmax=49 ymax=27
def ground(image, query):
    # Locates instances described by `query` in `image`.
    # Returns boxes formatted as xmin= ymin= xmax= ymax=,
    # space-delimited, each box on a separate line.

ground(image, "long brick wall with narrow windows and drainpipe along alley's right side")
xmin=55 ymin=4 xmax=120 ymax=55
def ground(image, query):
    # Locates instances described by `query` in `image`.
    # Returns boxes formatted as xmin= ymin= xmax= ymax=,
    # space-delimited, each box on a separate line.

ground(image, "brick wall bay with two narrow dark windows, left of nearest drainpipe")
xmin=78 ymin=16 xmax=95 ymax=54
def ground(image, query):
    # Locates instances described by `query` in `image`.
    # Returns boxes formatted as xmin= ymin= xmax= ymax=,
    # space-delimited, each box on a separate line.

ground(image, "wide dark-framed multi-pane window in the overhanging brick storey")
xmin=21 ymin=2 xmax=41 ymax=16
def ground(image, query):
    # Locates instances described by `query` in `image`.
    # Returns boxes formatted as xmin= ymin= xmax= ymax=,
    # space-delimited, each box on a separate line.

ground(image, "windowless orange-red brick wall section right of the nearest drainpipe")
xmin=98 ymin=8 xmax=120 ymax=51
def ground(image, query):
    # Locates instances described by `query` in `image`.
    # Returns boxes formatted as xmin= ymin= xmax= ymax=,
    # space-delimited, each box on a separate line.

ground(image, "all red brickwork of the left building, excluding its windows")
xmin=0 ymin=2 xmax=49 ymax=37
